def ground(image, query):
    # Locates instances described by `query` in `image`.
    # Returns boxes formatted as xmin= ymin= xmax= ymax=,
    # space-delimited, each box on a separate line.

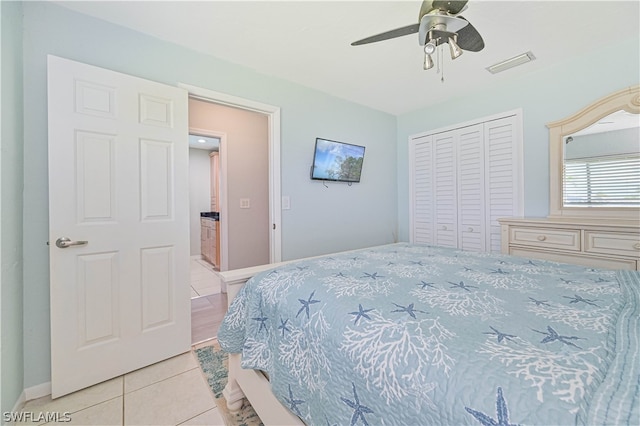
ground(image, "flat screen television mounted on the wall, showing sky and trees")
xmin=311 ymin=138 xmax=364 ymax=182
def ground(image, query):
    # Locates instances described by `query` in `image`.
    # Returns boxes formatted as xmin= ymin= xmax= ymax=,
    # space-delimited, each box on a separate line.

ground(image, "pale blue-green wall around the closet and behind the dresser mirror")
xmin=397 ymin=37 xmax=640 ymax=241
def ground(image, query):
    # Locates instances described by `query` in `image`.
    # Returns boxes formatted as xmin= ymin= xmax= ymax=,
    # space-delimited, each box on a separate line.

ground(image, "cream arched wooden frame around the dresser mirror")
xmin=547 ymin=85 xmax=640 ymax=220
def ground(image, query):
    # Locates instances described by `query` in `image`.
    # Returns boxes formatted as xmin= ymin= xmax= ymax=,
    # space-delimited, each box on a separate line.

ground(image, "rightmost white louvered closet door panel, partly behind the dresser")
xmin=484 ymin=116 xmax=522 ymax=253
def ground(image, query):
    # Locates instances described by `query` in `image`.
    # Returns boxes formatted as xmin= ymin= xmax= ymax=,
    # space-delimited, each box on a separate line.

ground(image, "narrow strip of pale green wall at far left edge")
xmin=0 ymin=2 xmax=24 ymax=414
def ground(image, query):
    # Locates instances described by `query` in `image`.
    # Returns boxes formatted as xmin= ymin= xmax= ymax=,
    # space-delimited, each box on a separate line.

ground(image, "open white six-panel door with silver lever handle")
xmin=48 ymin=56 xmax=191 ymax=398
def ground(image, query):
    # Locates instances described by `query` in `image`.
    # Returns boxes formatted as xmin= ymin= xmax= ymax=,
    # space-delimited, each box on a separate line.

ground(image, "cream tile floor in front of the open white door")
xmin=16 ymin=352 xmax=224 ymax=425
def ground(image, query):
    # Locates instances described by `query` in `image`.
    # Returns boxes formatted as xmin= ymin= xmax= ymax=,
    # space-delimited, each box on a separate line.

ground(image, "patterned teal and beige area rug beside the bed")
xmin=194 ymin=341 xmax=263 ymax=426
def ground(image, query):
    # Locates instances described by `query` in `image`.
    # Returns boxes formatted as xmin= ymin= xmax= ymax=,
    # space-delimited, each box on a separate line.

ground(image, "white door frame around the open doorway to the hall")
xmin=178 ymin=83 xmax=282 ymax=266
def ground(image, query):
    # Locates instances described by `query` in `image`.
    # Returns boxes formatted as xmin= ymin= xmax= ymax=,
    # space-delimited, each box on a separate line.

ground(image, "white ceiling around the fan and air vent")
xmin=56 ymin=0 xmax=640 ymax=115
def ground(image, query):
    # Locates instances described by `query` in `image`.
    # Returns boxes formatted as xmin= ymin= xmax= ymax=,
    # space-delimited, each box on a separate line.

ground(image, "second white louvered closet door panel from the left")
xmin=433 ymin=132 xmax=458 ymax=247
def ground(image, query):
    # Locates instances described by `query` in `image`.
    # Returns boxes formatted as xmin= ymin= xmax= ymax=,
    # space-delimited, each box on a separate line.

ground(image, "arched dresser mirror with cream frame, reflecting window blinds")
xmin=547 ymin=86 xmax=640 ymax=220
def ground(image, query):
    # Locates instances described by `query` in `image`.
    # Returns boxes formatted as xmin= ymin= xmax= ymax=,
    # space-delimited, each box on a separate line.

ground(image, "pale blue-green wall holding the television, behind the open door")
xmin=23 ymin=2 xmax=397 ymax=387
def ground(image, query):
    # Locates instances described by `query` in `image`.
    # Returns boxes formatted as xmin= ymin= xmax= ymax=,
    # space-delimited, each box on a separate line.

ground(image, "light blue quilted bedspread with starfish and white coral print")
xmin=218 ymin=243 xmax=640 ymax=426
